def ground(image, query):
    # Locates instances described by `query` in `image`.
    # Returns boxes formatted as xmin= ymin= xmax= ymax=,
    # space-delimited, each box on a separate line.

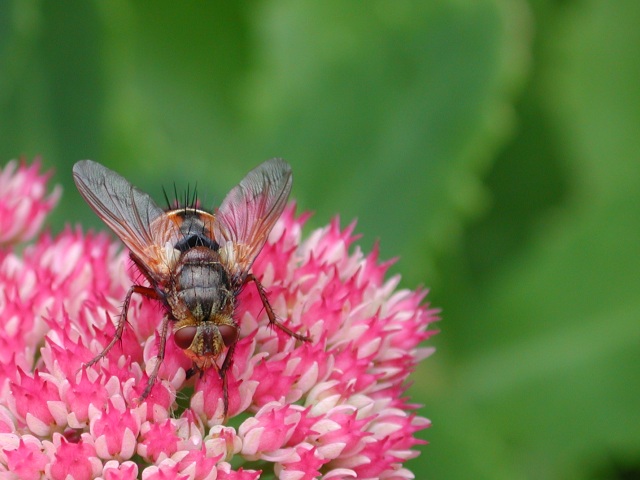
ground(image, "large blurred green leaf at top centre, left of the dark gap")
xmin=242 ymin=1 xmax=526 ymax=283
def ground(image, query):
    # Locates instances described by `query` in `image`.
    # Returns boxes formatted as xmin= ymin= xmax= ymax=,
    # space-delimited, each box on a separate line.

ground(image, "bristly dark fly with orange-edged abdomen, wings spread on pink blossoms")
xmin=73 ymin=159 xmax=310 ymax=416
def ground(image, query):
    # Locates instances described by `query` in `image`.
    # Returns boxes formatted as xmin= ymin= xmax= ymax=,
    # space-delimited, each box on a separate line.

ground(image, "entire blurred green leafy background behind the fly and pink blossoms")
xmin=0 ymin=0 xmax=640 ymax=479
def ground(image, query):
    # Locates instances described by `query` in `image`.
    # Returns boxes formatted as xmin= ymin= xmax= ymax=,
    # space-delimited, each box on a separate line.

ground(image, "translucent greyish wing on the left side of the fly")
xmin=73 ymin=160 xmax=180 ymax=280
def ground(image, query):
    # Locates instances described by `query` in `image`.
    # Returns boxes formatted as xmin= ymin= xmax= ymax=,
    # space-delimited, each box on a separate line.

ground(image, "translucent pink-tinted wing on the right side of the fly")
xmin=214 ymin=158 xmax=293 ymax=282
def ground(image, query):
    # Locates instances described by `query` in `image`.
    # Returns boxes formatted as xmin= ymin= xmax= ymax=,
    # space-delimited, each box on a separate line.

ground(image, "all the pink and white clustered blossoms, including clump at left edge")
xmin=0 ymin=164 xmax=437 ymax=480
